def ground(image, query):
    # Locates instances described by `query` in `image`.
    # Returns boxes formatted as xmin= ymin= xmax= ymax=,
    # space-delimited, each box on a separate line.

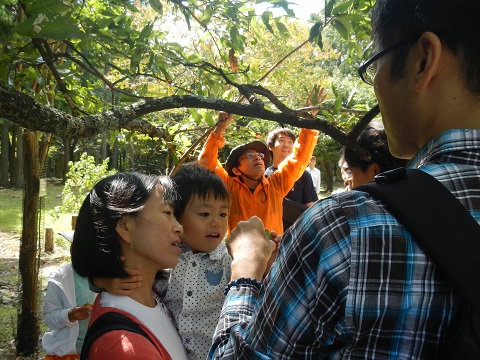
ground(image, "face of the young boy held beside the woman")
xmin=180 ymin=195 xmax=229 ymax=253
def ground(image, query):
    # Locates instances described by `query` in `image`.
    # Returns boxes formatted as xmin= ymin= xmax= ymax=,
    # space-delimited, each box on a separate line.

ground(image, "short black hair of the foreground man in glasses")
xmin=372 ymin=0 xmax=480 ymax=94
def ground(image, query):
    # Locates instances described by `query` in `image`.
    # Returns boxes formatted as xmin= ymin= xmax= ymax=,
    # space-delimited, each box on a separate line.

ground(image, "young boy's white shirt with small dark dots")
xmin=154 ymin=242 xmax=232 ymax=360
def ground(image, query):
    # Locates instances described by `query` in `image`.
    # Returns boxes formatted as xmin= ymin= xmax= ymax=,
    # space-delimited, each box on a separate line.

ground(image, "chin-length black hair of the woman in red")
xmin=72 ymin=172 xmax=177 ymax=278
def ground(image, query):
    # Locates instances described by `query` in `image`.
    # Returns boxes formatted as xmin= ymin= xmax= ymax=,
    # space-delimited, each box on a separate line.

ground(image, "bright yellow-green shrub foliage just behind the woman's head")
xmin=61 ymin=153 xmax=116 ymax=214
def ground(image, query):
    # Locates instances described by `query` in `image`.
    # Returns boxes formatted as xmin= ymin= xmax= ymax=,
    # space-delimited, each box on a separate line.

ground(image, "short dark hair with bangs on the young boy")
xmin=172 ymin=164 xmax=230 ymax=220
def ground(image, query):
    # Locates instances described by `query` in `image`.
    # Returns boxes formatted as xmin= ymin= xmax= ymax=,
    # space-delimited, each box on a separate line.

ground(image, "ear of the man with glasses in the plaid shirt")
xmin=415 ymin=31 xmax=442 ymax=91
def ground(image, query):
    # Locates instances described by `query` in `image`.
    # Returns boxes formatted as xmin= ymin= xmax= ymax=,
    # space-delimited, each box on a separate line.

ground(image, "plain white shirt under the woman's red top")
xmin=100 ymin=292 xmax=187 ymax=360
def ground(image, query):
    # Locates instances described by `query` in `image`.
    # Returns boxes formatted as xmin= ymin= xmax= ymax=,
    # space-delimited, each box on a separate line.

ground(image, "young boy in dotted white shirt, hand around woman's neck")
xmin=94 ymin=165 xmax=232 ymax=359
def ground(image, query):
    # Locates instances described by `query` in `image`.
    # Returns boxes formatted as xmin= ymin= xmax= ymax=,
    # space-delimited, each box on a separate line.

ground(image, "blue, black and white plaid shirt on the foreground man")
xmin=209 ymin=129 xmax=480 ymax=359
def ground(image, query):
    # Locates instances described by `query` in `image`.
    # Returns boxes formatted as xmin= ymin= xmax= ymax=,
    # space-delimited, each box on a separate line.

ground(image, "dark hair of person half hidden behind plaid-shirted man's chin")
xmin=342 ymin=124 xmax=408 ymax=172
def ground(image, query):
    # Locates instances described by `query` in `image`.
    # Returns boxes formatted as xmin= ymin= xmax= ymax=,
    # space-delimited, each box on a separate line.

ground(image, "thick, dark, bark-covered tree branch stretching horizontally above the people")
xmin=0 ymin=83 xmax=379 ymax=150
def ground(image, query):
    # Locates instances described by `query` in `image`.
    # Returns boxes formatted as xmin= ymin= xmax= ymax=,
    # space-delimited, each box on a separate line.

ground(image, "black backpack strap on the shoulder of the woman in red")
xmin=80 ymin=311 xmax=155 ymax=360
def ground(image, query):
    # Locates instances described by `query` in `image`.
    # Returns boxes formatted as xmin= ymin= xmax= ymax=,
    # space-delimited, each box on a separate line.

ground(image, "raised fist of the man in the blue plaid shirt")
xmin=225 ymin=216 xmax=276 ymax=281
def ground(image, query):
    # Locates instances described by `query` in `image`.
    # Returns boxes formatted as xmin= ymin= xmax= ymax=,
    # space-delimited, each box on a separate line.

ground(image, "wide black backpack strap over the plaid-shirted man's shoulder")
xmin=355 ymin=168 xmax=480 ymax=309
